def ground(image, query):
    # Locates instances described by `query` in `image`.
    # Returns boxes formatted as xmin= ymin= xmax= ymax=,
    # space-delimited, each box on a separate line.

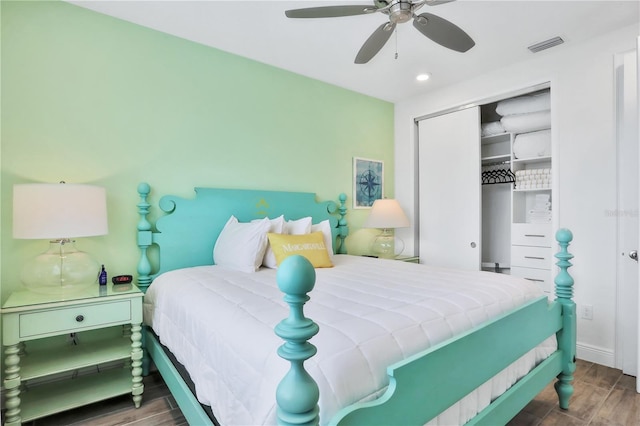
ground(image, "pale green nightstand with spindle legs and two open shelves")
xmin=1 ymin=284 xmax=144 ymax=426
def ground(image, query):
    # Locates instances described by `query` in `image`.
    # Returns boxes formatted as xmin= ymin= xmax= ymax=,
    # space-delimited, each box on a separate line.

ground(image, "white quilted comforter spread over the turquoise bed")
xmin=145 ymin=255 xmax=556 ymax=425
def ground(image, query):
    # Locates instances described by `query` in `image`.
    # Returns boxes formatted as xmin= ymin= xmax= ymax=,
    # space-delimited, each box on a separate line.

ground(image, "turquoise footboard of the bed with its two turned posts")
xmin=276 ymin=229 xmax=576 ymax=426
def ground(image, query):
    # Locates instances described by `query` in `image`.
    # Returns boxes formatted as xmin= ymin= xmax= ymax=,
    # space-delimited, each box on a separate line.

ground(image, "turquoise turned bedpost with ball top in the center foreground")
xmin=275 ymin=255 xmax=320 ymax=425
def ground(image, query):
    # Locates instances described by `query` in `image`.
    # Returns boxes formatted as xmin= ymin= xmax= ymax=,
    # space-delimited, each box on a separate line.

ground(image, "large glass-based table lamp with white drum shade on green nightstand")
xmin=13 ymin=182 xmax=108 ymax=293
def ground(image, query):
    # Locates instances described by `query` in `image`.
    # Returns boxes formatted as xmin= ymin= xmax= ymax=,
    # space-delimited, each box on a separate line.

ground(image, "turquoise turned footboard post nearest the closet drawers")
xmin=554 ymin=229 xmax=576 ymax=410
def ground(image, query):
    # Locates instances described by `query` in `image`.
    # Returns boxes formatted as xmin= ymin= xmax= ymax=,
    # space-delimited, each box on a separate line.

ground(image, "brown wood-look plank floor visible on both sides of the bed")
xmin=7 ymin=360 xmax=640 ymax=426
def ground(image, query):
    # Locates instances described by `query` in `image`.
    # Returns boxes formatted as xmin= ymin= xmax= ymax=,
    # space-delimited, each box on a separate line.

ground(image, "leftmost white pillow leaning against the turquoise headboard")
xmin=213 ymin=216 xmax=271 ymax=272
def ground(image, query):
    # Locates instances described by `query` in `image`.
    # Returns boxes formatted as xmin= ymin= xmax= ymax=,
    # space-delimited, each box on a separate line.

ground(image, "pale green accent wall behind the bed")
xmin=0 ymin=1 xmax=394 ymax=301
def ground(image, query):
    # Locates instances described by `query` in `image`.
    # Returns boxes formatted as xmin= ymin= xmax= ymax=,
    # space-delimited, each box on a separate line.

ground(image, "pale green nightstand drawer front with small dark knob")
xmin=20 ymin=300 xmax=131 ymax=338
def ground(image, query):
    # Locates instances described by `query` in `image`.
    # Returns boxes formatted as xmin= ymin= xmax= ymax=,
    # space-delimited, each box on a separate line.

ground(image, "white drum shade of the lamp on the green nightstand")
xmin=13 ymin=183 xmax=108 ymax=239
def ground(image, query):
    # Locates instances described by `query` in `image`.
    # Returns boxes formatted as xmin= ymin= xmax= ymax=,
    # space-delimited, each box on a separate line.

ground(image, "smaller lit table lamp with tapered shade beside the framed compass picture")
xmin=364 ymin=198 xmax=409 ymax=259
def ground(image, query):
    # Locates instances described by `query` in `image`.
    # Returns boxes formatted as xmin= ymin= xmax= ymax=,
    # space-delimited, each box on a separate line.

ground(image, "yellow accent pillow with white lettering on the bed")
xmin=267 ymin=231 xmax=333 ymax=268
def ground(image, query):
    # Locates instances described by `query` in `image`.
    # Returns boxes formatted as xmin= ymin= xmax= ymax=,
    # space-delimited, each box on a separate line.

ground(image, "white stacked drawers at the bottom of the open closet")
xmin=511 ymin=223 xmax=553 ymax=294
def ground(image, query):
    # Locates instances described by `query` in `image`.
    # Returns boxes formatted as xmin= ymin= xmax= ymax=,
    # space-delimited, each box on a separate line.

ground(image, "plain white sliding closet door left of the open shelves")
xmin=418 ymin=107 xmax=481 ymax=270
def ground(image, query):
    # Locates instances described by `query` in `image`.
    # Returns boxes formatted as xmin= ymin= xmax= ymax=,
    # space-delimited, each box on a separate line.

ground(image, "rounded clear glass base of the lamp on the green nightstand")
xmin=21 ymin=240 xmax=100 ymax=294
